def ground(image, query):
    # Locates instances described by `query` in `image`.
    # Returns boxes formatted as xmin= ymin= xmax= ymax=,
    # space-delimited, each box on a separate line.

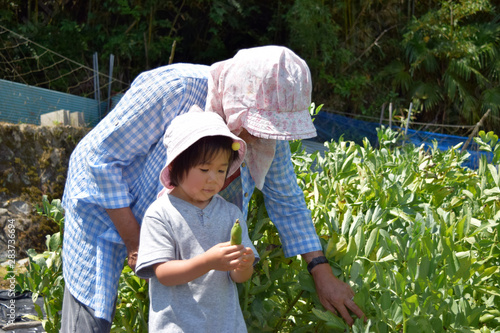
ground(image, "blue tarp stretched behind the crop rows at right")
xmin=314 ymin=111 xmax=492 ymax=169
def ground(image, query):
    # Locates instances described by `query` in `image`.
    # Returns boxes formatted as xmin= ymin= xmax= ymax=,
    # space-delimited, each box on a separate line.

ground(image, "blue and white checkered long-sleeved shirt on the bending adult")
xmin=63 ymin=64 xmax=321 ymax=321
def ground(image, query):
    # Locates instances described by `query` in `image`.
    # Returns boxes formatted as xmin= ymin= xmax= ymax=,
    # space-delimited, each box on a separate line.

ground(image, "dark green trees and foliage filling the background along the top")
xmin=0 ymin=0 xmax=500 ymax=135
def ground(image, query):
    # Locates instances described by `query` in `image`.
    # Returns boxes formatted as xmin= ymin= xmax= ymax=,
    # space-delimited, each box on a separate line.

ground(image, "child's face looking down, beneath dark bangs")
xmin=170 ymin=151 xmax=229 ymax=208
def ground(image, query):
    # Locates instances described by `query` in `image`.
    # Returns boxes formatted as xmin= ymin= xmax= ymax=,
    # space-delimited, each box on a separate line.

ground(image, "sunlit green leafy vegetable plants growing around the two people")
xmin=12 ymin=128 xmax=500 ymax=333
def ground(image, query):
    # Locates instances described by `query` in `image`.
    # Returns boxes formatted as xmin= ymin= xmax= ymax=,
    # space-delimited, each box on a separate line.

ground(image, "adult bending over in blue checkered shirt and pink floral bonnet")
xmin=62 ymin=46 xmax=364 ymax=332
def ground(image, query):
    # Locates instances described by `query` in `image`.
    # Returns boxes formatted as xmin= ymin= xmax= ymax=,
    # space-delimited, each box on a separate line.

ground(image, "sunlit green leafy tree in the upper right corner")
xmin=394 ymin=0 xmax=500 ymax=131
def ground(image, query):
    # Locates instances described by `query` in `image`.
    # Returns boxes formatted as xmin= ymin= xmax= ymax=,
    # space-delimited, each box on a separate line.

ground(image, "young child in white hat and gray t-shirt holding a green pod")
xmin=136 ymin=106 xmax=258 ymax=333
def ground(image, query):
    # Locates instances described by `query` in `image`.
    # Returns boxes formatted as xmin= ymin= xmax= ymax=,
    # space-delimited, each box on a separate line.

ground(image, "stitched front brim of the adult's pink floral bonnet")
xmin=243 ymin=109 xmax=317 ymax=140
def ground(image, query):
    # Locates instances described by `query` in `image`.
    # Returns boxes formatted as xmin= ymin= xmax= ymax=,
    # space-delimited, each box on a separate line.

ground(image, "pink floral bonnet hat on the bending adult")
xmin=206 ymin=45 xmax=317 ymax=140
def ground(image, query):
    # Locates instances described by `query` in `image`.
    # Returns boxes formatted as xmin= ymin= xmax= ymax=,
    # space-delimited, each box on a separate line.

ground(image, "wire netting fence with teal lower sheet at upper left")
xmin=0 ymin=25 xmax=129 ymax=124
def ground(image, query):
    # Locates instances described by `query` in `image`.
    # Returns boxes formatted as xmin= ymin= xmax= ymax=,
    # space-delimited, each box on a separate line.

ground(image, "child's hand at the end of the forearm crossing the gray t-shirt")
xmin=204 ymin=242 xmax=246 ymax=271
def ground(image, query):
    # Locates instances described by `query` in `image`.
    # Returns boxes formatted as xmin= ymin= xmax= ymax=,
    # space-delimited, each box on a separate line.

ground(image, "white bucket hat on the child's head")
xmin=160 ymin=105 xmax=247 ymax=189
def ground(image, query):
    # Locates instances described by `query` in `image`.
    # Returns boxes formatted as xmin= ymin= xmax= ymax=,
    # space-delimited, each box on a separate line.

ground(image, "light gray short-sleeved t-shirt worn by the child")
xmin=136 ymin=195 xmax=258 ymax=333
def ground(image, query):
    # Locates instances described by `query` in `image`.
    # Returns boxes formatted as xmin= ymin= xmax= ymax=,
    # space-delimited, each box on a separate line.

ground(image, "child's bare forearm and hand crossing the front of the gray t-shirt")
xmin=153 ymin=242 xmax=245 ymax=286
